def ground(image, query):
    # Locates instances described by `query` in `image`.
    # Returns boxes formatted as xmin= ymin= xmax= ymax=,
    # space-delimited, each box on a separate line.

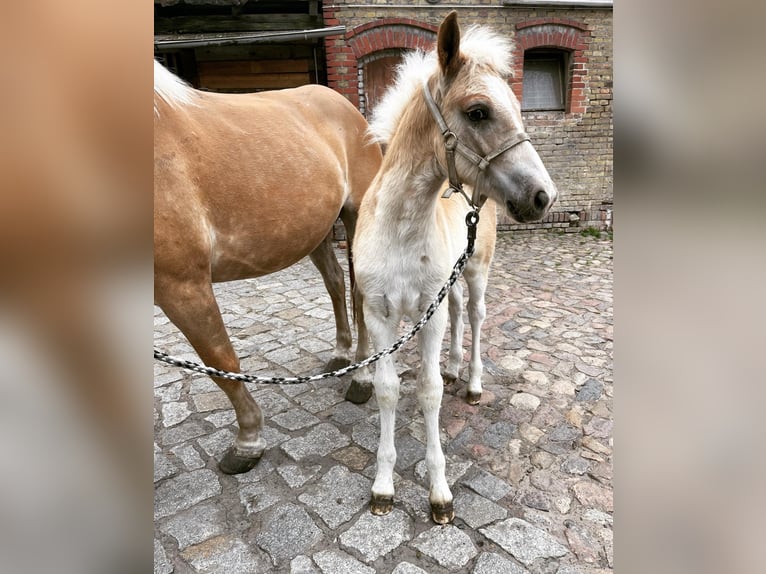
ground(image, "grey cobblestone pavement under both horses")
xmin=154 ymin=233 xmax=613 ymax=574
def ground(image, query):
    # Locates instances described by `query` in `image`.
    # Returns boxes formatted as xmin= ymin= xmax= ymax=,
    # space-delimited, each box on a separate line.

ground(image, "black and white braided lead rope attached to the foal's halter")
xmin=154 ymin=209 xmax=479 ymax=385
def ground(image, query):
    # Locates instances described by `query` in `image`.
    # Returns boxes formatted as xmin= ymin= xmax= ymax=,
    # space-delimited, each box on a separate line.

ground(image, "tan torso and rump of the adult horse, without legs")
xmin=154 ymin=85 xmax=380 ymax=281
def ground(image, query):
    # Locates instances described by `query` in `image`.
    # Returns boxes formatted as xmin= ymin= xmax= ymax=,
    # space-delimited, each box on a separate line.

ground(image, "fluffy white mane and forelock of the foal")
xmin=369 ymin=26 xmax=512 ymax=143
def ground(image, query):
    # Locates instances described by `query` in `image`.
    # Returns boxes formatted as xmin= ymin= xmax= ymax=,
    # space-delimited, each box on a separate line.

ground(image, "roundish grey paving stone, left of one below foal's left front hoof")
xmin=255 ymin=504 xmax=322 ymax=566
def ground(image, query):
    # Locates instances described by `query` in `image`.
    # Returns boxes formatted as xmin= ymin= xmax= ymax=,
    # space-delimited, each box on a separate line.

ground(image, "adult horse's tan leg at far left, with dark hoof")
xmin=157 ymin=283 xmax=266 ymax=474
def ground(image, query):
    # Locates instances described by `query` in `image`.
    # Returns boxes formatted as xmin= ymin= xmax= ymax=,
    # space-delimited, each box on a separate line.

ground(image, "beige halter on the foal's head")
xmin=423 ymin=82 xmax=529 ymax=209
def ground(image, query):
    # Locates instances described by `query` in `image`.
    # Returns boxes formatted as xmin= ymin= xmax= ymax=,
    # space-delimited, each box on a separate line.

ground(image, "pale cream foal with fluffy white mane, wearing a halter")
xmin=354 ymin=12 xmax=557 ymax=523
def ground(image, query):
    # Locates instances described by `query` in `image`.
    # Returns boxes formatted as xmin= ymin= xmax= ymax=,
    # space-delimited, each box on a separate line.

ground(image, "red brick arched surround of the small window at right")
xmin=511 ymin=18 xmax=591 ymax=114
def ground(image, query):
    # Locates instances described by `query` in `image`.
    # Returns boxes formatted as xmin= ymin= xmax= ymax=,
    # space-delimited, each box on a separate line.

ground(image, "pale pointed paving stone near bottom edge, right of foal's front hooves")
xmin=479 ymin=518 xmax=569 ymax=566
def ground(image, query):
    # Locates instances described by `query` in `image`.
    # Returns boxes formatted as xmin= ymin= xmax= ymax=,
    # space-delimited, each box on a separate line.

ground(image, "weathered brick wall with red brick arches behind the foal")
xmin=323 ymin=0 xmax=613 ymax=232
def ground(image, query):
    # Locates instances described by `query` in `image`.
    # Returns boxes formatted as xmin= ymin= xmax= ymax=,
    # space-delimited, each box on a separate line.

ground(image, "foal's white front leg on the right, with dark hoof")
xmin=417 ymin=311 xmax=455 ymax=524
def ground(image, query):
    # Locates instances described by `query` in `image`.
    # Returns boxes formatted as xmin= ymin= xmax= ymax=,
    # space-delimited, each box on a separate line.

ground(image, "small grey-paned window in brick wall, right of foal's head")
xmin=521 ymin=49 xmax=569 ymax=111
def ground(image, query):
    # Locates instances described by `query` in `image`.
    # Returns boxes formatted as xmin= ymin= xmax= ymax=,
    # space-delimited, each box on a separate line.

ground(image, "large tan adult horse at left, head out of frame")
xmin=154 ymin=62 xmax=381 ymax=473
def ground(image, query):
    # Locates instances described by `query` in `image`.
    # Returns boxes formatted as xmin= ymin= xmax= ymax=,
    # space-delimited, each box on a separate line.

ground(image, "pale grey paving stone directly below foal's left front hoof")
xmin=340 ymin=508 xmax=412 ymax=563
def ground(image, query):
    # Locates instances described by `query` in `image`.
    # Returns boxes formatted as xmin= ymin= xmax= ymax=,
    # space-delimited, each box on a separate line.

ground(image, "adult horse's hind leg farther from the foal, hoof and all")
xmin=309 ymin=235 xmax=351 ymax=371
